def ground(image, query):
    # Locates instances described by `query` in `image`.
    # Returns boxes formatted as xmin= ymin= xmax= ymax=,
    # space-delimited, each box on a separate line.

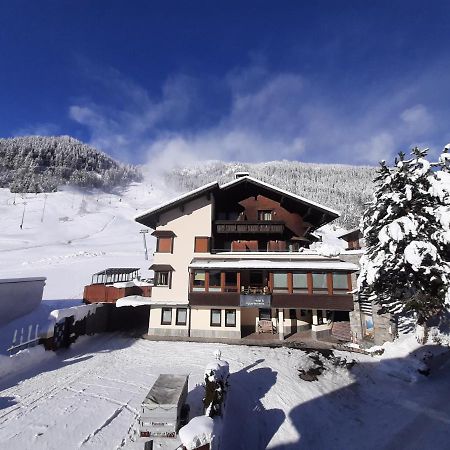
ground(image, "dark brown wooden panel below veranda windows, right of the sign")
xmin=272 ymin=293 xmax=353 ymax=311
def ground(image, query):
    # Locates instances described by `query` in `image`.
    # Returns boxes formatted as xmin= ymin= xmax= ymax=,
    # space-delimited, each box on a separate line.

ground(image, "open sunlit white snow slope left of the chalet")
xmin=0 ymin=183 xmax=171 ymax=299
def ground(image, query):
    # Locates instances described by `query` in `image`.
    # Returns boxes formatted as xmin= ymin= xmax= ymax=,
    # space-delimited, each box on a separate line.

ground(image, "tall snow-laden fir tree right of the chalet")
xmin=358 ymin=148 xmax=450 ymax=336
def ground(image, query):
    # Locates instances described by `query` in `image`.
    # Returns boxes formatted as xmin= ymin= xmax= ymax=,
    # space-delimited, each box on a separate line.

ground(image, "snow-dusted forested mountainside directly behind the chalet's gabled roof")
xmin=166 ymin=161 xmax=376 ymax=228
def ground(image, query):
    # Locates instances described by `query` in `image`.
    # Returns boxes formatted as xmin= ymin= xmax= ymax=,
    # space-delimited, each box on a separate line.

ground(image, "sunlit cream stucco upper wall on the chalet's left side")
xmin=152 ymin=196 xmax=213 ymax=304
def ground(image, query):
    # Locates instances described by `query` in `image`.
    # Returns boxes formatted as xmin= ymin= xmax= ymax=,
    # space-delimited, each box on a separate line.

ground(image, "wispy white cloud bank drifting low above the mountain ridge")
xmin=69 ymin=59 xmax=444 ymax=170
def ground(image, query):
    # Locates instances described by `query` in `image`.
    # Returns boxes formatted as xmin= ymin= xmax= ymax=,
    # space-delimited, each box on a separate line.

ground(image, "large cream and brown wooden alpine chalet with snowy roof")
xmin=135 ymin=173 xmax=358 ymax=339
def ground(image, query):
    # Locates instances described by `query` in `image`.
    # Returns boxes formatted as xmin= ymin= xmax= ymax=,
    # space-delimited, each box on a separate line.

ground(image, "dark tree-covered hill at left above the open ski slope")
xmin=0 ymin=136 xmax=141 ymax=192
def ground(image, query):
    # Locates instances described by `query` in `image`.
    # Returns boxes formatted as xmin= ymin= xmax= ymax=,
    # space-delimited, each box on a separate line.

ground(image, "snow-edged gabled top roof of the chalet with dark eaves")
xmin=134 ymin=176 xmax=340 ymax=228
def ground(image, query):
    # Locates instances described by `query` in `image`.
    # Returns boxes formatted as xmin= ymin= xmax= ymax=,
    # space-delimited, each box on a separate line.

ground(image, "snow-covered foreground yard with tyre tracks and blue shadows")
xmin=0 ymin=334 xmax=450 ymax=450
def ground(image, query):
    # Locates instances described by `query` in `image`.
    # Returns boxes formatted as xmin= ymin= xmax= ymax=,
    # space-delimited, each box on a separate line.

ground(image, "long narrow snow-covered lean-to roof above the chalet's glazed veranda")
xmin=189 ymin=258 xmax=359 ymax=271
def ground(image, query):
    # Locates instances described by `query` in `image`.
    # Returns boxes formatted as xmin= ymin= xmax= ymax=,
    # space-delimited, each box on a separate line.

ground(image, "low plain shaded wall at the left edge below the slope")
xmin=0 ymin=277 xmax=46 ymax=325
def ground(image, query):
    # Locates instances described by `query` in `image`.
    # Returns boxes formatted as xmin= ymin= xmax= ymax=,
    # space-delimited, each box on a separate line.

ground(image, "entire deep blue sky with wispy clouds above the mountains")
xmin=0 ymin=0 xmax=450 ymax=165
